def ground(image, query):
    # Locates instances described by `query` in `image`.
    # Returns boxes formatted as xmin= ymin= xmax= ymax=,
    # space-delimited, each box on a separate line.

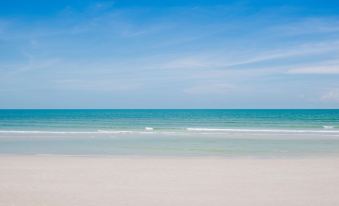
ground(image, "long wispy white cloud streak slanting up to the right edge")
xmin=162 ymin=41 xmax=339 ymax=70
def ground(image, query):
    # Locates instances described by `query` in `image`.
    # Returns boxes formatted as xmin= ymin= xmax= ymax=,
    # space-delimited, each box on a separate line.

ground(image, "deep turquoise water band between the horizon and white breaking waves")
xmin=0 ymin=110 xmax=339 ymax=131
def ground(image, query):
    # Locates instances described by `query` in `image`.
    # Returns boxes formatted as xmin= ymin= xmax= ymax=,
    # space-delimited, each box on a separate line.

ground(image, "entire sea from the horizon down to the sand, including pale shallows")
xmin=0 ymin=110 xmax=339 ymax=156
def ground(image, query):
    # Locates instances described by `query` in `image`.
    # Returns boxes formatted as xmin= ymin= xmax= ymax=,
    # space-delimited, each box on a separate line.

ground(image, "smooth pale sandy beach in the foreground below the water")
xmin=0 ymin=155 xmax=339 ymax=206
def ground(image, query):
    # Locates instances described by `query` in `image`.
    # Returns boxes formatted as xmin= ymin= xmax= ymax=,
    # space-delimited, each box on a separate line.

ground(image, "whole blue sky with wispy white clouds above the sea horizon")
xmin=0 ymin=0 xmax=339 ymax=109
